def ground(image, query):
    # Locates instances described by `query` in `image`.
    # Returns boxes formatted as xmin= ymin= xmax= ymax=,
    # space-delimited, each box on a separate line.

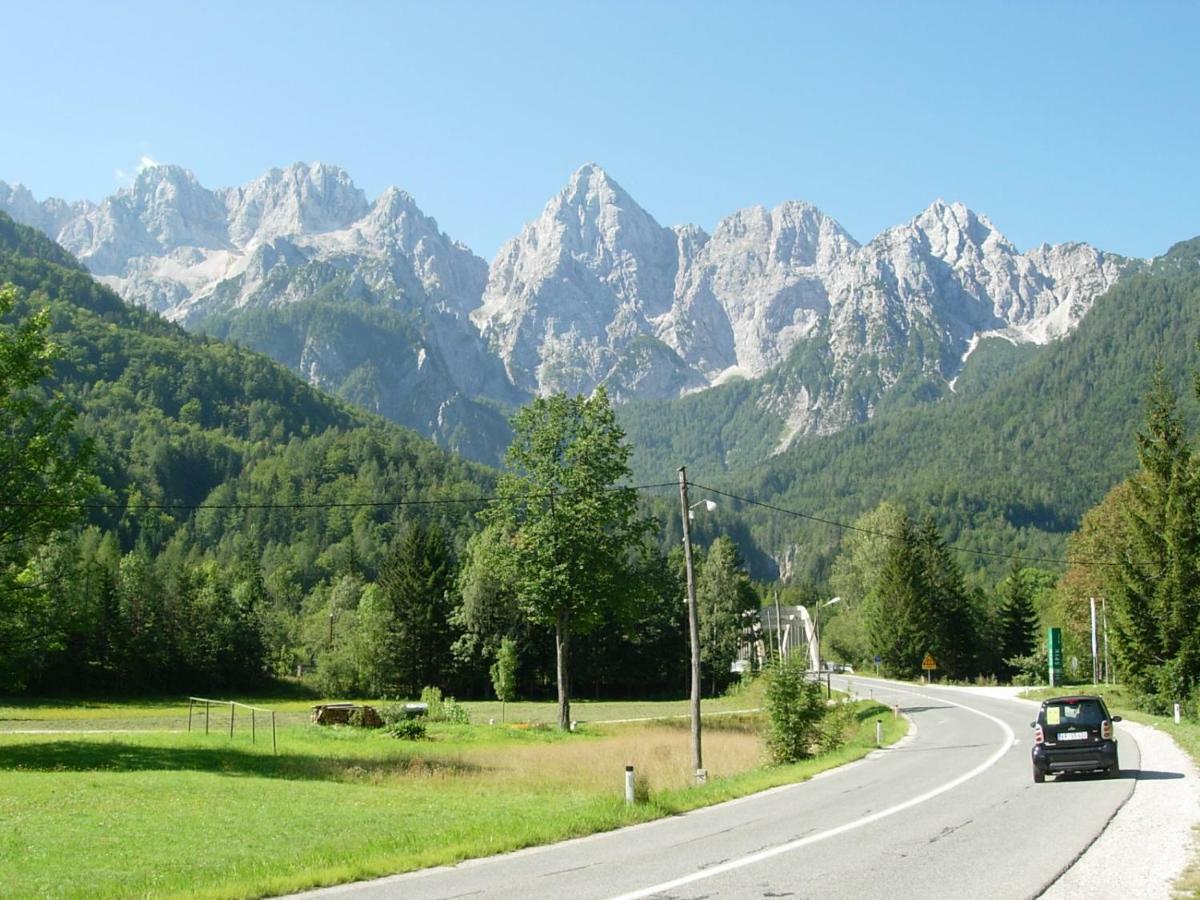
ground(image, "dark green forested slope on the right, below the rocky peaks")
xmin=700 ymin=239 xmax=1200 ymax=576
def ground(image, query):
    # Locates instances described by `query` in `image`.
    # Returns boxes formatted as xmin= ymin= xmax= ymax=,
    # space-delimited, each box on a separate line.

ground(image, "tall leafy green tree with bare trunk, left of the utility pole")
xmin=484 ymin=388 xmax=650 ymax=728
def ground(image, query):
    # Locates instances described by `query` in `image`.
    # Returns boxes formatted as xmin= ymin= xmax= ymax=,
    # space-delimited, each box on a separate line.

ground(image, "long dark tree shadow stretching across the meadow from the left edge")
xmin=0 ymin=740 xmax=482 ymax=784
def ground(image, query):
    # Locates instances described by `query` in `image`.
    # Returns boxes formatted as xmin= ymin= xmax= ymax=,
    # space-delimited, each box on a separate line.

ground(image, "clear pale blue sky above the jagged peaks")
xmin=0 ymin=0 xmax=1200 ymax=259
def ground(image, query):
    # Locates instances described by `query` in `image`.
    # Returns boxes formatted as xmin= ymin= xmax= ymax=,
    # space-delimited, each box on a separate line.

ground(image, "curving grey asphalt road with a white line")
xmin=295 ymin=678 xmax=1140 ymax=900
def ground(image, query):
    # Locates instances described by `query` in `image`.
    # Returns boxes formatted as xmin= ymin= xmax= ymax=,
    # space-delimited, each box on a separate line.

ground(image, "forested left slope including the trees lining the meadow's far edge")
xmin=0 ymin=216 xmax=715 ymax=696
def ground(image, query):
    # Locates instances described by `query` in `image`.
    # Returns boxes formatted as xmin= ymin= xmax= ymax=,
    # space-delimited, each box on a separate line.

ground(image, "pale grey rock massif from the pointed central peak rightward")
xmin=473 ymin=164 xmax=1128 ymax=444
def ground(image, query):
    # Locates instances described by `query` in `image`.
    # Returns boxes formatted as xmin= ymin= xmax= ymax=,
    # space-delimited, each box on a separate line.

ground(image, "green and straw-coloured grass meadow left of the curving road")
xmin=0 ymin=698 xmax=905 ymax=898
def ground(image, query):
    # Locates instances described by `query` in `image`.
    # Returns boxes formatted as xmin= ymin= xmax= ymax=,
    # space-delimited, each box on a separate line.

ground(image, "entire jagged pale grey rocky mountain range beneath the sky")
xmin=0 ymin=163 xmax=1139 ymax=464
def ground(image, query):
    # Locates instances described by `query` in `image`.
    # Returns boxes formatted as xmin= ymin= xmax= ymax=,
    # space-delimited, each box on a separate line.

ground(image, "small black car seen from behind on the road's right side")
xmin=1030 ymin=695 xmax=1121 ymax=784
